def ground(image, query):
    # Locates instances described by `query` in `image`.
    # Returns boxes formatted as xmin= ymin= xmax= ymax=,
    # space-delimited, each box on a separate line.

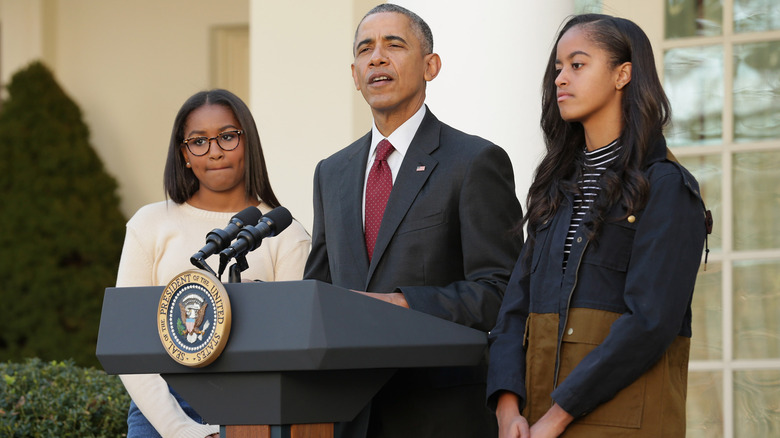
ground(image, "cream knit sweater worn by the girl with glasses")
xmin=116 ymin=201 xmax=311 ymax=438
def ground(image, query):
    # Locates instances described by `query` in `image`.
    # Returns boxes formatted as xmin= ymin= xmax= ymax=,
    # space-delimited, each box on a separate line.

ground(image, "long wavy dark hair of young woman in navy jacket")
xmin=523 ymin=14 xmax=671 ymax=245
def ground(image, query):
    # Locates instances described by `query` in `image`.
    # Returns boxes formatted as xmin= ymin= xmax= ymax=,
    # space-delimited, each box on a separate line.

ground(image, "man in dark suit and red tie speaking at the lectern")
xmin=304 ymin=4 xmax=522 ymax=438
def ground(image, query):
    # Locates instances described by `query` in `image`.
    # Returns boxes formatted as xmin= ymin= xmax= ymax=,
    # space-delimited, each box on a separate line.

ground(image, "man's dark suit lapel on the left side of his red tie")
xmin=339 ymin=132 xmax=371 ymax=276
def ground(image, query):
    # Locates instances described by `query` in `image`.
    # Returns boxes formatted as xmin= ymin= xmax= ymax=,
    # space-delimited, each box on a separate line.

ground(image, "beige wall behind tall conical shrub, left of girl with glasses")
xmin=0 ymin=0 xmax=249 ymax=216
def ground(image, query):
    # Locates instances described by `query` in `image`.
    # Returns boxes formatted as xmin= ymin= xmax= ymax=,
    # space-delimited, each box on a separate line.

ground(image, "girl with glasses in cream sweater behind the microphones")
xmin=117 ymin=89 xmax=311 ymax=438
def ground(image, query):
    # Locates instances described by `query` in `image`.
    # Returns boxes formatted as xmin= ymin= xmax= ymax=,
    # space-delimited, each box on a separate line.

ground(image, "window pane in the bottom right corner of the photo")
xmin=734 ymin=370 xmax=780 ymax=438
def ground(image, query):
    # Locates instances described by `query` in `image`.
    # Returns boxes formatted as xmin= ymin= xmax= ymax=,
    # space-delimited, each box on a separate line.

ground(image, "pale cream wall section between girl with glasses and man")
xmin=250 ymin=0 xmax=373 ymax=231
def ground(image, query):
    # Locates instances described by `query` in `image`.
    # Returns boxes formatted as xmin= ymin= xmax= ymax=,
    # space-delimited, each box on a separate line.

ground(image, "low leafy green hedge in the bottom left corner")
xmin=0 ymin=359 xmax=130 ymax=438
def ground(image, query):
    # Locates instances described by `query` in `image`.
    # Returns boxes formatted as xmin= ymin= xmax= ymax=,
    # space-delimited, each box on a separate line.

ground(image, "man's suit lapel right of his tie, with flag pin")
xmin=364 ymin=110 xmax=441 ymax=289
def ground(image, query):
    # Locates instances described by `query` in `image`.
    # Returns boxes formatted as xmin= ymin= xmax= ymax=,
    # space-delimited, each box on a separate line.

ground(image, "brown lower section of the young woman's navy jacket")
xmin=523 ymin=308 xmax=690 ymax=438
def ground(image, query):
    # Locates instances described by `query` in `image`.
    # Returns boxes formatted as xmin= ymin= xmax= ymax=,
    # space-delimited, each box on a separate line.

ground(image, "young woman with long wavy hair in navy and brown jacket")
xmin=488 ymin=14 xmax=706 ymax=438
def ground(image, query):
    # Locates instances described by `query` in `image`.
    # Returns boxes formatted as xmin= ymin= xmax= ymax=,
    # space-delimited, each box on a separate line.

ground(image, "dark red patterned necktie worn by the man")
xmin=366 ymin=140 xmax=393 ymax=261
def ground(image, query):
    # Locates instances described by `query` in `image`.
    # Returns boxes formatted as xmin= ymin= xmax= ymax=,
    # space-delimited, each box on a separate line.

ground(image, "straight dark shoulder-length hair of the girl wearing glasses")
xmin=163 ymin=89 xmax=280 ymax=208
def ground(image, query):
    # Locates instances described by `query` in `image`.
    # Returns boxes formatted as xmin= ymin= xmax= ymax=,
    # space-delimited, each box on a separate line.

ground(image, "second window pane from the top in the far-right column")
xmin=734 ymin=40 xmax=780 ymax=141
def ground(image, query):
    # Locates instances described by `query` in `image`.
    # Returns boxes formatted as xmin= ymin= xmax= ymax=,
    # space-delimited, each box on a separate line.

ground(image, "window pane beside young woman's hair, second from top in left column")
xmin=664 ymin=46 xmax=723 ymax=146
